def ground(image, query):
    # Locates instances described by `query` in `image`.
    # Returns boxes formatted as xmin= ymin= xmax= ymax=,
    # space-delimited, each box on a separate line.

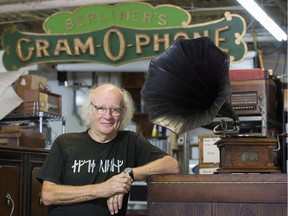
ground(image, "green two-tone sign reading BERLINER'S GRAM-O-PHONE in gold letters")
xmin=2 ymin=2 xmax=247 ymax=71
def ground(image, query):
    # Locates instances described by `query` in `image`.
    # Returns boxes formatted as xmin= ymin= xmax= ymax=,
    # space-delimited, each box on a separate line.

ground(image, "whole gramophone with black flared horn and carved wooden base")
xmin=141 ymin=37 xmax=279 ymax=173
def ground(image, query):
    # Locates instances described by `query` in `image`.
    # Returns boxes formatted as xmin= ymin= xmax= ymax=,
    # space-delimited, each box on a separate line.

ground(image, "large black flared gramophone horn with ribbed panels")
xmin=141 ymin=37 xmax=239 ymax=134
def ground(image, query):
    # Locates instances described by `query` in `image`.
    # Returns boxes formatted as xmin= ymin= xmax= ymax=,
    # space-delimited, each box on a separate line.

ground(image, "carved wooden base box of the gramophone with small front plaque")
xmin=215 ymin=137 xmax=280 ymax=173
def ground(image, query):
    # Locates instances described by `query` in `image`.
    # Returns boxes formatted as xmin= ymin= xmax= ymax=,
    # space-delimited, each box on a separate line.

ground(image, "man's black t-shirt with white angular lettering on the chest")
xmin=37 ymin=131 xmax=167 ymax=216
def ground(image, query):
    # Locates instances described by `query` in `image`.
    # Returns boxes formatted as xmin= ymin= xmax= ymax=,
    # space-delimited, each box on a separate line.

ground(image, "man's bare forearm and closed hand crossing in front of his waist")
xmin=41 ymin=173 xmax=132 ymax=205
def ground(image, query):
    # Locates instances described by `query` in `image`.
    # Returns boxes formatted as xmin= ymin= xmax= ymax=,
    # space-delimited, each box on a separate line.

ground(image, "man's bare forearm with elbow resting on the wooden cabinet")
xmin=133 ymin=155 xmax=181 ymax=181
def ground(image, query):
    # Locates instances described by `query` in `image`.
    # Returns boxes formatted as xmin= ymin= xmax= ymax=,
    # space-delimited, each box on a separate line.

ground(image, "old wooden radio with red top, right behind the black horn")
xmin=229 ymin=69 xmax=277 ymax=117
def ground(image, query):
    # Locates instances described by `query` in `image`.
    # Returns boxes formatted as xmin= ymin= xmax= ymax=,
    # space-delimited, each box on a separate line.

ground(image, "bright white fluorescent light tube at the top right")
xmin=237 ymin=0 xmax=287 ymax=41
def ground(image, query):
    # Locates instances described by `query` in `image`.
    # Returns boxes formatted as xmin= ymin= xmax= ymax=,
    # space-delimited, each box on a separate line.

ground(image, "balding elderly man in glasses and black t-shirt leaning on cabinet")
xmin=38 ymin=84 xmax=180 ymax=216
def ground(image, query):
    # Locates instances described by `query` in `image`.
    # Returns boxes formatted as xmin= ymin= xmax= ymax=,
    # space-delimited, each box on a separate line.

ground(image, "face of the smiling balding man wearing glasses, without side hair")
xmin=91 ymin=85 xmax=122 ymax=136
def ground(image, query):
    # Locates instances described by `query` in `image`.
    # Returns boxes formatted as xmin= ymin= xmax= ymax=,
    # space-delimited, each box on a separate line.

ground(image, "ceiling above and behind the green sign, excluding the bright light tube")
xmin=0 ymin=0 xmax=287 ymax=48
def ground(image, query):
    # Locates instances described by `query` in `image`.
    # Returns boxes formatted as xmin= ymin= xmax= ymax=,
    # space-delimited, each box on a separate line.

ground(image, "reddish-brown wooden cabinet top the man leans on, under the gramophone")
xmin=148 ymin=174 xmax=287 ymax=216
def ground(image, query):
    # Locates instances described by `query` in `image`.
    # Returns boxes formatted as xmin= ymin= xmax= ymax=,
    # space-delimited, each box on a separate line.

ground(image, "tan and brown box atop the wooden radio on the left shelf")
xmin=16 ymin=74 xmax=48 ymax=99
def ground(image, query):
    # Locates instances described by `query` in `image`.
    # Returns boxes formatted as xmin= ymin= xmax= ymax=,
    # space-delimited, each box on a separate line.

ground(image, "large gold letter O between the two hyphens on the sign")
xmin=103 ymin=29 xmax=125 ymax=61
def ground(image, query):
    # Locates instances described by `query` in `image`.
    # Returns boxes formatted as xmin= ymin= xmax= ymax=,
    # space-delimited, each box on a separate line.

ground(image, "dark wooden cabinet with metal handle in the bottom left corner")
xmin=0 ymin=146 xmax=48 ymax=216
